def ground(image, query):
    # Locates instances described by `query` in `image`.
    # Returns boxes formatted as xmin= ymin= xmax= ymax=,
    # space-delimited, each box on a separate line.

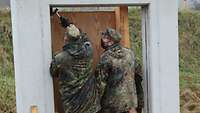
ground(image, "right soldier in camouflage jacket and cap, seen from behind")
xmin=96 ymin=28 xmax=137 ymax=113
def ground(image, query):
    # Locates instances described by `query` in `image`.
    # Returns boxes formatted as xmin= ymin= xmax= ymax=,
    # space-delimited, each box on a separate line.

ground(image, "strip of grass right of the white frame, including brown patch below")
xmin=179 ymin=11 xmax=200 ymax=113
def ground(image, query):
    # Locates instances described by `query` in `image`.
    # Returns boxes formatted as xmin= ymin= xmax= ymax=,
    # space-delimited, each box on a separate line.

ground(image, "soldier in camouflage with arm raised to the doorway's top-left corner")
xmin=50 ymin=10 xmax=100 ymax=113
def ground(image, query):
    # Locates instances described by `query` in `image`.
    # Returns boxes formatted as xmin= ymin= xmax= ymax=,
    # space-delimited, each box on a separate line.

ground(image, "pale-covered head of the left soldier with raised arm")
xmin=64 ymin=24 xmax=80 ymax=42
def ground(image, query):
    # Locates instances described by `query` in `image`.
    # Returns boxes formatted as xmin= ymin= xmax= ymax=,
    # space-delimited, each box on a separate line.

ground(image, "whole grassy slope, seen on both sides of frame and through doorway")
xmin=0 ymin=9 xmax=200 ymax=113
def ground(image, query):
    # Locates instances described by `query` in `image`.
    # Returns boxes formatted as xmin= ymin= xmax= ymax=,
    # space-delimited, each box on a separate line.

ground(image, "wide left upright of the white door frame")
xmin=11 ymin=0 xmax=54 ymax=113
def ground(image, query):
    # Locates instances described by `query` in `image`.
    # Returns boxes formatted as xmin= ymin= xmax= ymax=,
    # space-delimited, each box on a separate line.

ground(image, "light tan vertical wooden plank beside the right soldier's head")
xmin=115 ymin=6 xmax=130 ymax=48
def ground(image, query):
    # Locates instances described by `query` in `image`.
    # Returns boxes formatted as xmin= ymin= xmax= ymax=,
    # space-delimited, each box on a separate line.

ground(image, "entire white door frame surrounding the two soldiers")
xmin=11 ymin=0 xmax=180 ymax=113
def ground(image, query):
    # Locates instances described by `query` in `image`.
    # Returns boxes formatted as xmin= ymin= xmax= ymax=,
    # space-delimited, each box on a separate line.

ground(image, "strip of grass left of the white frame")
xmin=0 ymin=10 xmax=16 ymax=113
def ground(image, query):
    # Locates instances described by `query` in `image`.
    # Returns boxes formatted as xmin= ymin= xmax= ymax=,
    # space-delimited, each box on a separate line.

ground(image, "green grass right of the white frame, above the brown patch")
xmin=179 ymin=11 xmax=200 ymax=90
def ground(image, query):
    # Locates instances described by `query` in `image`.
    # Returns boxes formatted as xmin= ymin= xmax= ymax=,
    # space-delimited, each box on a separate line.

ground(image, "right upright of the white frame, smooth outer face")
xmin=147 ymin=0 xmax=180 ymax=113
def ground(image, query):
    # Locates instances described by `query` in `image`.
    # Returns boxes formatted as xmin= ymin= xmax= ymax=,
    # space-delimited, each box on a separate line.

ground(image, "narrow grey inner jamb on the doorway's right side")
xmin=142 ymin=6 xmax=151 ymax=113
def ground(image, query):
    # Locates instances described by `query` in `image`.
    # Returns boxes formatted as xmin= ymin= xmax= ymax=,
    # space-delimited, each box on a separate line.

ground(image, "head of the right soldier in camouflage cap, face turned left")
xmin=101 ymin=28 xmax=121 ymax=49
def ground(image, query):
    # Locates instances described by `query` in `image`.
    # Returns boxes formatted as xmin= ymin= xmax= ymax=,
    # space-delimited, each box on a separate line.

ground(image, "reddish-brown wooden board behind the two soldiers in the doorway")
xmin=51 ymin=11 xmax=116 ymax=113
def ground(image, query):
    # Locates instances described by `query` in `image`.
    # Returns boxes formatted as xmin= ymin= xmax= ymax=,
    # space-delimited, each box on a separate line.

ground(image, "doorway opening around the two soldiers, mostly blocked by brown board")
xmin=50 ymin=5 xmax=150 ymax=113
